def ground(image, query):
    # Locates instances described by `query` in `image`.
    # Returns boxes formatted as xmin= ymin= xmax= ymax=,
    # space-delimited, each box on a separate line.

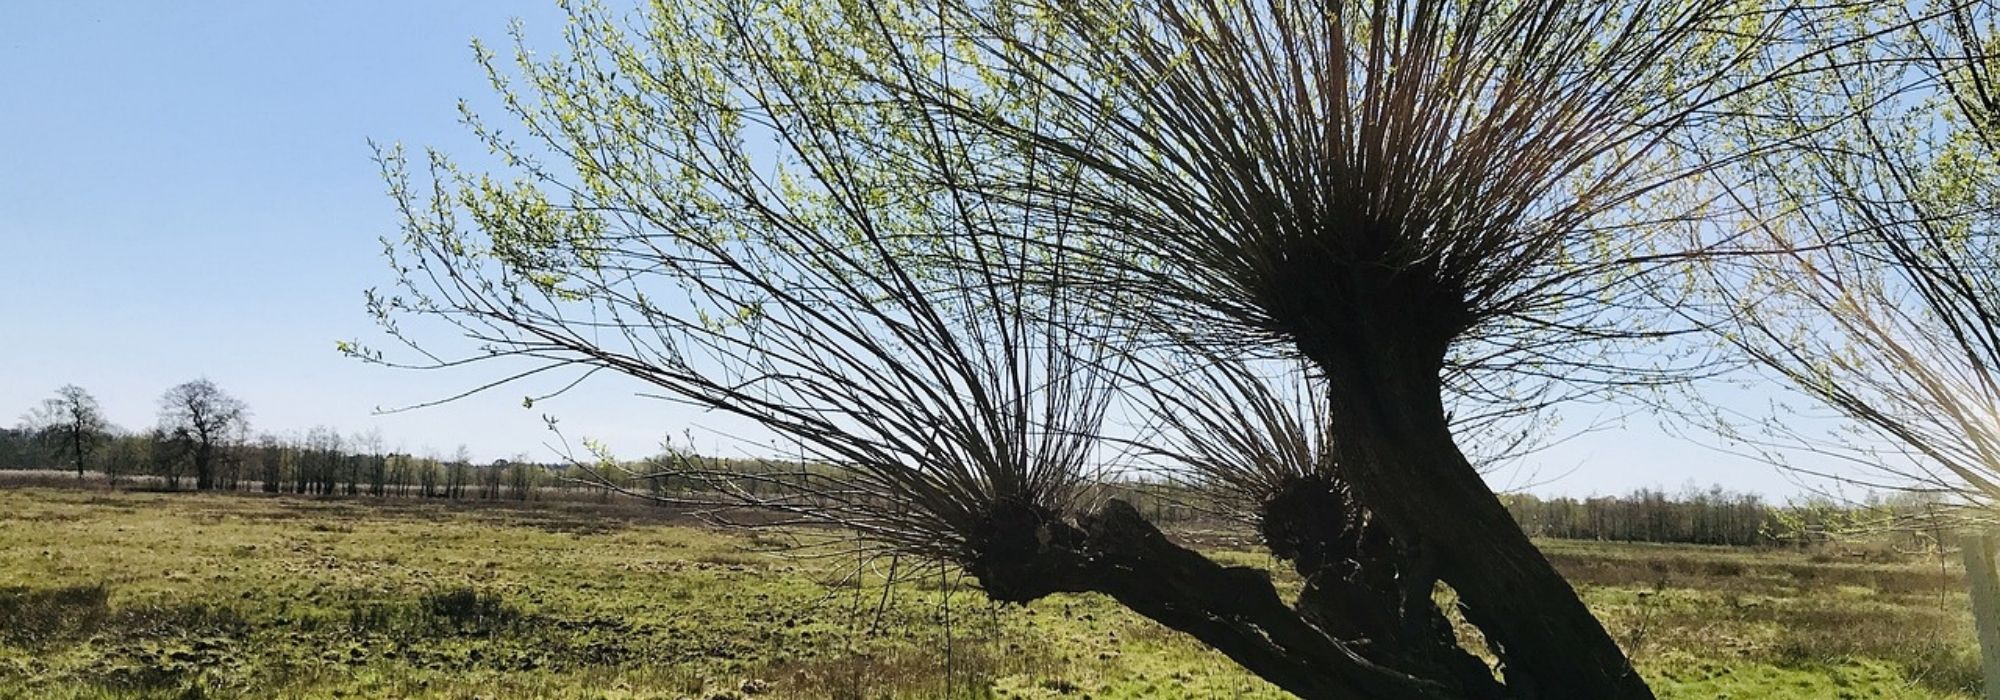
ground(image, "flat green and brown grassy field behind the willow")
xmin=0 ymin=488 xmax=1978 ymax=700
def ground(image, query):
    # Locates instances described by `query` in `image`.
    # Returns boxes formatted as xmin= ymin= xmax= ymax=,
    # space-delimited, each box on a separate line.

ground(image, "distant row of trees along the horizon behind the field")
xmin=0 ymin=428 xmax=1930 ymax=546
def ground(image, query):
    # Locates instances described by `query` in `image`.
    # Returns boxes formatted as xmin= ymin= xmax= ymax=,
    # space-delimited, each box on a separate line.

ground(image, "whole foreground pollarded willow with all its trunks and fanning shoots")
xmin=348 ymin=0 xmax=1872 ymax=698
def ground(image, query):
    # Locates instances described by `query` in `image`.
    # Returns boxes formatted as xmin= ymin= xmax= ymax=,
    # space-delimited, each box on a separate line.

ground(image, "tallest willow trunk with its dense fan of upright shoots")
xmin=808 ymin=2 xmax=1840 ymax=696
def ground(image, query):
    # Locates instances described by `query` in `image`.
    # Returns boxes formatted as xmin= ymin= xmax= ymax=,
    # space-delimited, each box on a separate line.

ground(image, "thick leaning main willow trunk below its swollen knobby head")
xmin=1300 ymin=294 xmax=1652 ymax=698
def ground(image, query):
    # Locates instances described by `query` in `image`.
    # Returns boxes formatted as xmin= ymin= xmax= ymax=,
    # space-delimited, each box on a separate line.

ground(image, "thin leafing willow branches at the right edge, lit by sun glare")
xmin=1694 ymin=0 xmax=2000 ymax=504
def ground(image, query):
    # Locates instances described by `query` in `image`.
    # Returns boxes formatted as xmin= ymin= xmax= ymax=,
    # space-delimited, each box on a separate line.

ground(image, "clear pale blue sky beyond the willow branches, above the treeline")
xmin=0 ymin=0 xmax=1832 ymax=498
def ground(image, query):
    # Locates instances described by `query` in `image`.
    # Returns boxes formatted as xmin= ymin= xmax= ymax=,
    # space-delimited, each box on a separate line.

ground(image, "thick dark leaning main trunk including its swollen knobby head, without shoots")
xmin=1262 ymin=253 xmax=1652 ymax=700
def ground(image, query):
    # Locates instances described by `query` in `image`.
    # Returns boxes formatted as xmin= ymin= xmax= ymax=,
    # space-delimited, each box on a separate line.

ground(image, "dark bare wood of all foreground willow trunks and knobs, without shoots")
xmin=968 ymin=254 xmax=1652 ymax=700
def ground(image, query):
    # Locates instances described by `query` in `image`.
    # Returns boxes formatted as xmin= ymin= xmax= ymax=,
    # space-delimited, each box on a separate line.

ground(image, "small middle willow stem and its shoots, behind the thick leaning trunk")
xmin=1104 ymin=346 xmax=1532 ymax=698
